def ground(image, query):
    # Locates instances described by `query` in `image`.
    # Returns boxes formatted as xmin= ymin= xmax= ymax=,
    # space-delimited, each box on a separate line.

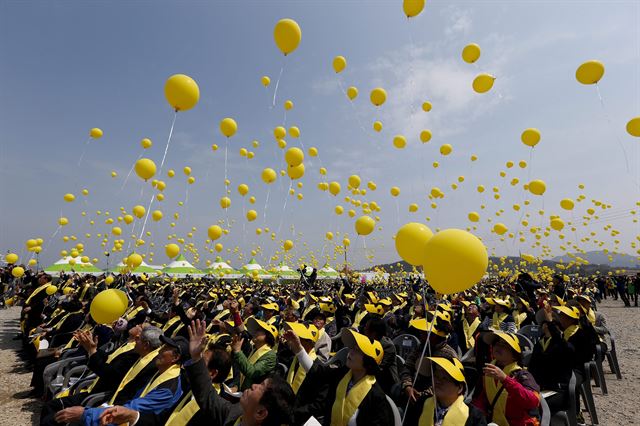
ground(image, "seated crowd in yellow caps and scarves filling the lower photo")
xmin=0 ymin=267 xmax=628 ymax=426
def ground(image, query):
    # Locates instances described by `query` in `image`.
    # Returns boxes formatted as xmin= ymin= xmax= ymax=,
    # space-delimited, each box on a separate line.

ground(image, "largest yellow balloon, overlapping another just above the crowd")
xmin=423 ymin=229 xmax=489 ymax=294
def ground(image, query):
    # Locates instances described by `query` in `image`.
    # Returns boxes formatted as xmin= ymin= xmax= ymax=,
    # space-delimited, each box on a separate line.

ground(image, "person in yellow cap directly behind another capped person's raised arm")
xmin=283 ymin=322 xmax=329 ymax=425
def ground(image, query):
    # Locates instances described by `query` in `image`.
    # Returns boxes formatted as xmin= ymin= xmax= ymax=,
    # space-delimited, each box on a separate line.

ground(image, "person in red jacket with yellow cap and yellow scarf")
xmin=473 ymin=331 xmax=540 ymax=426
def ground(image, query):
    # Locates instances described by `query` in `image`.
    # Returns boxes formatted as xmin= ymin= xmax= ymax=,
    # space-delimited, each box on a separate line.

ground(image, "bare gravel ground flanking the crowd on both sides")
xmin=0 ymin=299 xmax=640 ymax=426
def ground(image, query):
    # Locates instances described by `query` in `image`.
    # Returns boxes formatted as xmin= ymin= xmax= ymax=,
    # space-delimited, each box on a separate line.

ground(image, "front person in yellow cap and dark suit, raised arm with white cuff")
xmin=285 ymin=329 xmax=394 ymax=426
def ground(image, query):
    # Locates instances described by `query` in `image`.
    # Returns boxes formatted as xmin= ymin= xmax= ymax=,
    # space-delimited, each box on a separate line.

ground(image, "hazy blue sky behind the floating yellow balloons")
xmin=0 ymin=1 xmax=640 ymax=266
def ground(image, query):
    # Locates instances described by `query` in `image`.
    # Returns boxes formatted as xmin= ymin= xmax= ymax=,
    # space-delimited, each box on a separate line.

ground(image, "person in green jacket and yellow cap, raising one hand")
xmin=231 ymin=317 xmax=278 ymax=391
